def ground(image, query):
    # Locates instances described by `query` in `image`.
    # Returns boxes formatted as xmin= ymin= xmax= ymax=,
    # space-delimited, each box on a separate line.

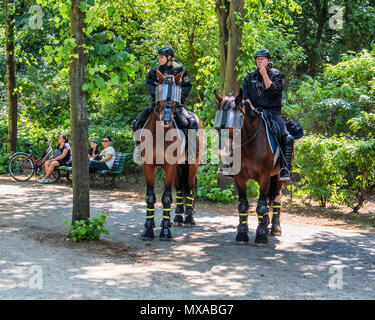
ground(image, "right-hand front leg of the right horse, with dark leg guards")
xmin=255 ymin=174 xmax=270 ymax=246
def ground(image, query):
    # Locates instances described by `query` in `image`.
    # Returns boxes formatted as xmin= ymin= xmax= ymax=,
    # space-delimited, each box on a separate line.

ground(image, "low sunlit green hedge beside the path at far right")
xmin=293 ymin=135 xmax=375 ymax=211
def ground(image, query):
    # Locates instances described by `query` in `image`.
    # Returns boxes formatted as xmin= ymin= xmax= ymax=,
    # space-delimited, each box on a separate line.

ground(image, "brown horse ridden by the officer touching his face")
xmin=215 ymin=89 xmax=285 ymax=246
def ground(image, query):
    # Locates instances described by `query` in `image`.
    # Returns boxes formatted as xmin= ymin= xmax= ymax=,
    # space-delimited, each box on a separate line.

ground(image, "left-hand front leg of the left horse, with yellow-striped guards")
xmin=141 ymin=164 xmax=156 ymax=241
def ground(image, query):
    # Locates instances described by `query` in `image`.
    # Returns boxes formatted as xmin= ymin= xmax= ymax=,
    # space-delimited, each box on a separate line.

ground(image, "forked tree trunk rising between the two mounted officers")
xmin=216 ymin=0 xmax=244 ymax=95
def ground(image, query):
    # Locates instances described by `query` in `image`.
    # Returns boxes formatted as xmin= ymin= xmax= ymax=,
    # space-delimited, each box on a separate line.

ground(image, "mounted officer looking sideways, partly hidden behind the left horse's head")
xmin=132 ymin=46 xmax=198 ymax=134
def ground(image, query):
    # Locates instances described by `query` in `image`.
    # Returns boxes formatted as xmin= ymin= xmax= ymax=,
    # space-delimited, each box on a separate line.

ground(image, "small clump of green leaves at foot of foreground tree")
xmin=64 ymin=210 xmax=109 ymax=242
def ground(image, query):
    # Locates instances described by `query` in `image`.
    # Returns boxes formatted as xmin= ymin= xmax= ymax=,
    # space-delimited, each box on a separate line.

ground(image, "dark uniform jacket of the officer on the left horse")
xmin=146 ymin=63 xmax=192 ymax=104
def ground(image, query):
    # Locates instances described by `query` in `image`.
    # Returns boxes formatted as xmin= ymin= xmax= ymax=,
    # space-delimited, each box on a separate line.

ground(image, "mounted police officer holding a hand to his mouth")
xmin=243 ymin=49 xmax=294 ymax=181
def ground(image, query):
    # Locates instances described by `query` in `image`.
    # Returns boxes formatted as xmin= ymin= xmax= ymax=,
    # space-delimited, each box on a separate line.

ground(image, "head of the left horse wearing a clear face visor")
xmin=155 ymin=69 xmax=183 ymax=125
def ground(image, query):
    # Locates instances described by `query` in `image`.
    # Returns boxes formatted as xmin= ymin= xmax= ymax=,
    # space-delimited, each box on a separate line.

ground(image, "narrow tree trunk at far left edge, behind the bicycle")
xmin=4 ymin=0 xmax=17 ymax=152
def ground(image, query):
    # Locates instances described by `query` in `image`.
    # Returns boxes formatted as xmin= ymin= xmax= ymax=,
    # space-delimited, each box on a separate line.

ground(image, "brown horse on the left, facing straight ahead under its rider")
xmin=141 ymin=70 xmax=203 ymax=241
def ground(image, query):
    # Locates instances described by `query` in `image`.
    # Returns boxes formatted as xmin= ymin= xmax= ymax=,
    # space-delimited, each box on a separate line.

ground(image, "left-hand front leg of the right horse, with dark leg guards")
xmin=234 ymin=176 xmax=249 ymax=244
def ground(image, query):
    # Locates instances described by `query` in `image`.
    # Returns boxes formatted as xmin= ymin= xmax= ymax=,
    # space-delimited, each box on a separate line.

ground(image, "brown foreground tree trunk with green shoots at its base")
xmin=69 ymin=0 xmax=90 ymax=224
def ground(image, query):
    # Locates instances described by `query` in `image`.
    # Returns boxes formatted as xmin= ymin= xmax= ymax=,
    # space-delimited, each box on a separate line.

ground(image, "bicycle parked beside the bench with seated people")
xmin=8 ymin=140 xmax=59 ymax=182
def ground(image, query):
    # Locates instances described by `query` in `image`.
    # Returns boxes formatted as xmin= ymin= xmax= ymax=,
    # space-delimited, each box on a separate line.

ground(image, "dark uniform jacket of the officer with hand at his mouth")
xmin=243 ymin=68 xmax=285 ymax=112
